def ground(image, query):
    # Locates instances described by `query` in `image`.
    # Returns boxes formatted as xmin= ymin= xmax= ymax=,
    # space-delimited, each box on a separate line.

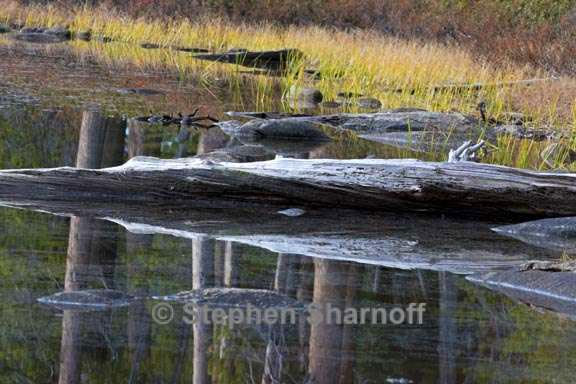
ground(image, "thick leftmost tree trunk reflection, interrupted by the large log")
xmin=58 ymin=108 xmax=125 ymax=384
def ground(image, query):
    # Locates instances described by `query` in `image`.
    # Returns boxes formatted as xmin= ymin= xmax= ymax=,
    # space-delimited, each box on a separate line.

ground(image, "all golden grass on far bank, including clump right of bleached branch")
xmin=0 ymin=0 xmax=576 ymax=167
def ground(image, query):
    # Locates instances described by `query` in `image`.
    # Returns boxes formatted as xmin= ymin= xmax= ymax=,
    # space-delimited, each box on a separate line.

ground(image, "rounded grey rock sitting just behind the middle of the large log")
xmin=221 ymin=119 xmax=330 ymax=141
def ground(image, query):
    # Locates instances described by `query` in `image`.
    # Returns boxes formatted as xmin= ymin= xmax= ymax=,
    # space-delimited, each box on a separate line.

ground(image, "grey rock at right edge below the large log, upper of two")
xmin=492 ymin=217 xmax=576 ymax=253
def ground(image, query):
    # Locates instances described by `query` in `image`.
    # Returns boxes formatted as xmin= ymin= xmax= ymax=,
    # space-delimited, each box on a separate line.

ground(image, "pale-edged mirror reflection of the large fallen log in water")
xmin=0 ymin=201 xmax=559 ymax=273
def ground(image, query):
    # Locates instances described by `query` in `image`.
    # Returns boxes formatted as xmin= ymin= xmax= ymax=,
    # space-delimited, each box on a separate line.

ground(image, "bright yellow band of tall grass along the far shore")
xmin=0 ymin=4 xmax=537 ymax=112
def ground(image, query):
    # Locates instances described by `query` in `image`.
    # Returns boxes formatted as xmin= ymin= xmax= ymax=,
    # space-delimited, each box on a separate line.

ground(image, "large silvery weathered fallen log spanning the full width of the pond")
xmin=0 ymin=157 xmax=576 ymax=217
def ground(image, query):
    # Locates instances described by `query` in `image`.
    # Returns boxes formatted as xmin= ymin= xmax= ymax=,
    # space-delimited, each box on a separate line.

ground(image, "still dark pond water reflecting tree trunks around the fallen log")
xmin=0 ymin=40 xmax=576 ymax=384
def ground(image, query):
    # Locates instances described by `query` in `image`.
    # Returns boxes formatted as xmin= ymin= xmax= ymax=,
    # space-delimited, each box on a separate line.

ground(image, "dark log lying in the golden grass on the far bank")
xmin=192 ymin=49 xmax=303 ymax=70
